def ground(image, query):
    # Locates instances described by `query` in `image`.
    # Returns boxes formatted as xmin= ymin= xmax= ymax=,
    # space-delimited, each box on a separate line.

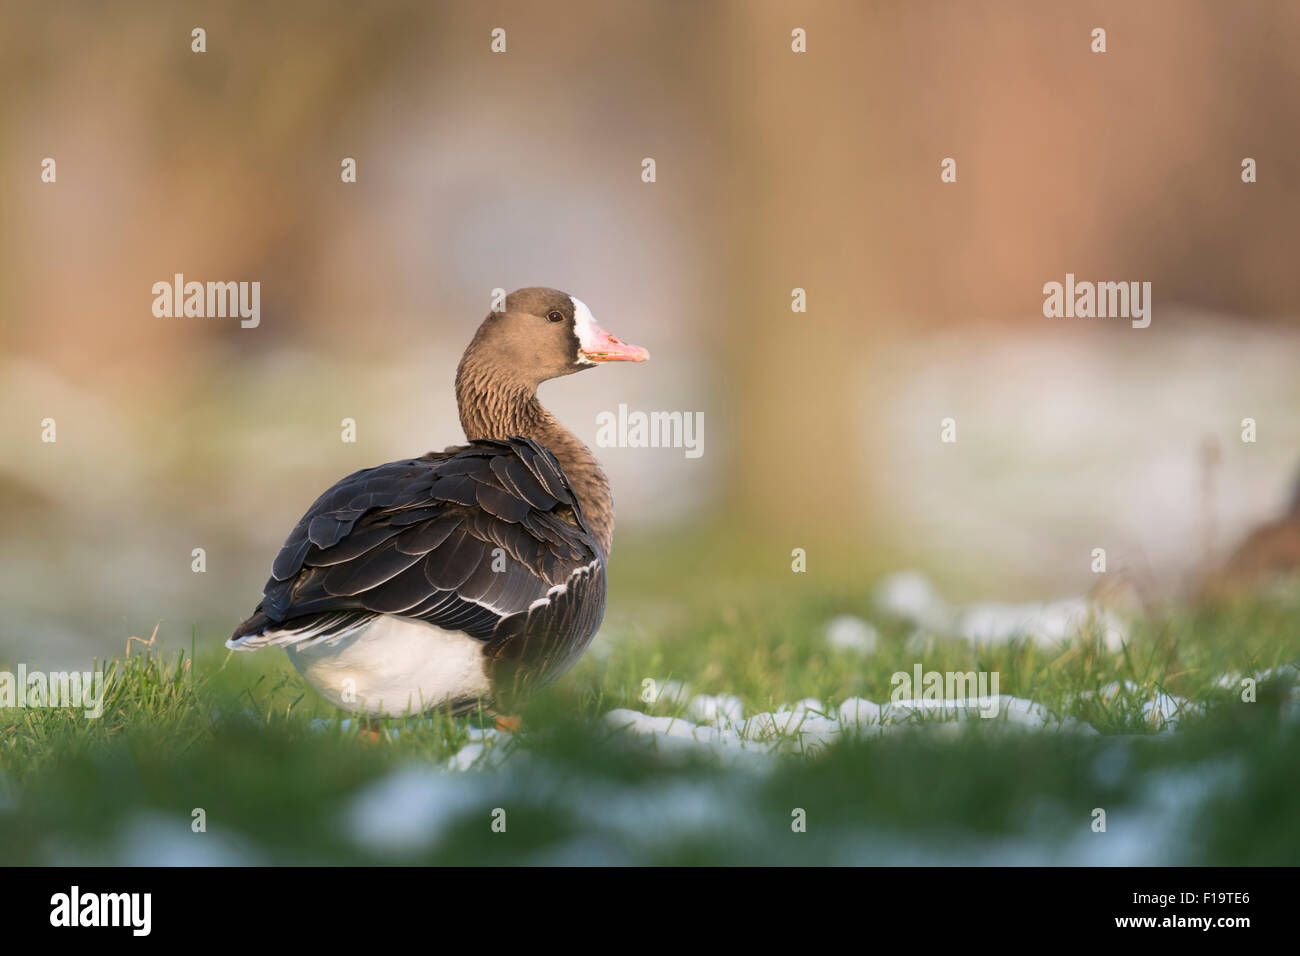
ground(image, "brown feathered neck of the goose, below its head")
xmin=456 ymin=352 xmax=614 ymax=557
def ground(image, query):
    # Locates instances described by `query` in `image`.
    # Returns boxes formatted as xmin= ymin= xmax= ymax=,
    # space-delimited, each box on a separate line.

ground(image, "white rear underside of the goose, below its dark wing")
xmin=287 ymin=615 xmax=489 ymax=717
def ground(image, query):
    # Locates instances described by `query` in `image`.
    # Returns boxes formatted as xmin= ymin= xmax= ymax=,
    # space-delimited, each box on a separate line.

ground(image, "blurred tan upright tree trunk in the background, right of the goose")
xmin=725 ymin=3 xmax=899 ymax=548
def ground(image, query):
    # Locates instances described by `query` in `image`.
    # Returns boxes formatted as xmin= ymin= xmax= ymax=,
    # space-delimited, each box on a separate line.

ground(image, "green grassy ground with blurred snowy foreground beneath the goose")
xmin=0 ymin=546 xmax=1300 ymax=864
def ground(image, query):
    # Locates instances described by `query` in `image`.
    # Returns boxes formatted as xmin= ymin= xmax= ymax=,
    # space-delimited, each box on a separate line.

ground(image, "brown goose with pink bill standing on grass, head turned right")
xmin=226 ymin=287 xmax=650 ymax=726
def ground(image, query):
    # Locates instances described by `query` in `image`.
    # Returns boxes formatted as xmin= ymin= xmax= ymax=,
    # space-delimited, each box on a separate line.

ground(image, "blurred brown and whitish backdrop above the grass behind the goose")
xmin=0 ymin=0 xmax=1300 ymax=666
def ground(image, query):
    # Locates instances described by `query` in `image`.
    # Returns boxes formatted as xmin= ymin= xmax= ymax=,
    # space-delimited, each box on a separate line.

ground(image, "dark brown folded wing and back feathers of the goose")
xmin=231 ymin=438 xmax=605 ymax=665
